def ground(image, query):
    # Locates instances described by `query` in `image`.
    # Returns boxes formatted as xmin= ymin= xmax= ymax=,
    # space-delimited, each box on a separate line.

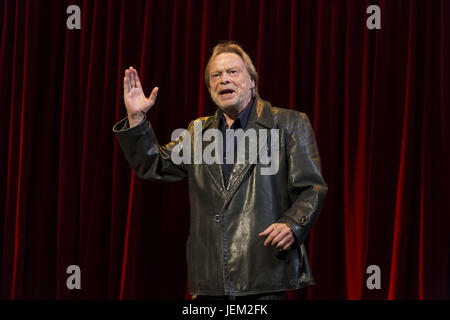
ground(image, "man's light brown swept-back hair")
xmin=205 ymin=41 xmax=258 ymax=97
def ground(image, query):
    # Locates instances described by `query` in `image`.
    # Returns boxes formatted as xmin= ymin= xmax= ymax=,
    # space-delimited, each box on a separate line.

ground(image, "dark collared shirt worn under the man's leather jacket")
xmin=219 ymin=98 xmax=254 ymax=187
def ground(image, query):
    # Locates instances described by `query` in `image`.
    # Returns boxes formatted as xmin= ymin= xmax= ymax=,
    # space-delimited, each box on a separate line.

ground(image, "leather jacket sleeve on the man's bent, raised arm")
xmin=112 ymin=118 xmax=187 ymax=181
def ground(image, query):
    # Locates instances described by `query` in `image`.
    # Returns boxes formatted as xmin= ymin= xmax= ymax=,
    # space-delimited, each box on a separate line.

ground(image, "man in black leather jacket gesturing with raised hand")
xmin=113 ymin=42 xmax=327 ymax=299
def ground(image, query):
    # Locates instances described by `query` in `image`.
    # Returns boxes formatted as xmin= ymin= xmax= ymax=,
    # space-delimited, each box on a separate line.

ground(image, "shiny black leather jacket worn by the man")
xmin=113 ymin=97 xmax=327 ymax=296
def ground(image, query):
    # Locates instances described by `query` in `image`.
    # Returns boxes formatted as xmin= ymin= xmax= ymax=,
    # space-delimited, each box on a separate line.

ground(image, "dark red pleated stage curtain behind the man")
xmin=0 ymin=0 xmax=450 ymax=299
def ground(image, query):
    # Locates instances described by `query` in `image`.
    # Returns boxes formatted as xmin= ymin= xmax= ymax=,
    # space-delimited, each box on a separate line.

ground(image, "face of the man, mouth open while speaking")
xmin=209 ymin=52 xmax=255 ymax=113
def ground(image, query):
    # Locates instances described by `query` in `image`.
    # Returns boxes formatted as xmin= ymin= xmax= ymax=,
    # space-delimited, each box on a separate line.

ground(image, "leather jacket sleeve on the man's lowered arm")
xmin=277 ymin=113 xmax=328 ymax=244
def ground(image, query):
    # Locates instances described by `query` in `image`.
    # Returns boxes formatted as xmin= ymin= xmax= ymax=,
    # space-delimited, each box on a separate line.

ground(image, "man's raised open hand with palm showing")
xmin=123 ymin=67 xmax=158 ymax=128
